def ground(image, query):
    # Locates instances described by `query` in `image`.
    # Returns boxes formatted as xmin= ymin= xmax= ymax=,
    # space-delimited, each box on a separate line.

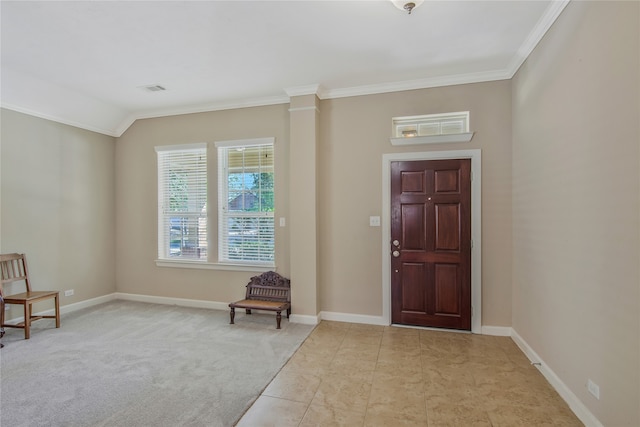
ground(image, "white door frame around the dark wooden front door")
xmin=381 ymin=149 xmax=482 ymax=334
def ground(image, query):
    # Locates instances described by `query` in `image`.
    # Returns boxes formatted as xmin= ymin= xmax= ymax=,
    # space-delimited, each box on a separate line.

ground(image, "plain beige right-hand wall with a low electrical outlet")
xmin=513 ymin=2 xmax=640 ymax=426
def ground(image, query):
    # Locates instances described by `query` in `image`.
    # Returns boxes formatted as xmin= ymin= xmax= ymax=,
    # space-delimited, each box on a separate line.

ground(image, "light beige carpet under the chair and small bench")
xmin=0 ymin=301 xmax=313 ymax=427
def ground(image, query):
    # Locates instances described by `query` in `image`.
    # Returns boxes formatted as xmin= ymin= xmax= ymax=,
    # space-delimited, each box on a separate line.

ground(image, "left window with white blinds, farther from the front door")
xmin=156 ymin=143 xmax=207 ymax=261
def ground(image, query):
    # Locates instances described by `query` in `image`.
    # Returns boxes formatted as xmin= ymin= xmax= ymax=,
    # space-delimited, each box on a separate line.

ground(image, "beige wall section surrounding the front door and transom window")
xmin=318 ymin=81 xmax=511 ymax=326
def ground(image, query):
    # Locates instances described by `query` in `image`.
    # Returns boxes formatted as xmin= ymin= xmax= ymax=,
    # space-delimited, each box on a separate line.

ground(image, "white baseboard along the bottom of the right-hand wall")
xmin=511 ymin=330 xmax=604 ymax=427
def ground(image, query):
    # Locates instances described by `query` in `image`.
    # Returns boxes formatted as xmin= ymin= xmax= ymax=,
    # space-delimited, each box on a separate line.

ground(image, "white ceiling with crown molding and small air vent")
xmin=0 ymin=0 xmax=567 ymax=136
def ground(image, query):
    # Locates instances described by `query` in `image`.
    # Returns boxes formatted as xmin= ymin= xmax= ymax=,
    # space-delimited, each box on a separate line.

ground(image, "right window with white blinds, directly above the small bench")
xmin=216 ymin=138 xmax=275 ymax=265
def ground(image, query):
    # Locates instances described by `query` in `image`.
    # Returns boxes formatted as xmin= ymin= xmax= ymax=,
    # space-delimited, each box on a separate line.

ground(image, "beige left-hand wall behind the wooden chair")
xmin=0 ymin=109 xmax=115 ymax=317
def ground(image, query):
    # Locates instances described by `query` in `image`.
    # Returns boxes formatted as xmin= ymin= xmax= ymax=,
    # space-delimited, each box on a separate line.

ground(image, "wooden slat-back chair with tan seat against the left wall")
xmin=0 ymin=254 xmax=60 ymax=340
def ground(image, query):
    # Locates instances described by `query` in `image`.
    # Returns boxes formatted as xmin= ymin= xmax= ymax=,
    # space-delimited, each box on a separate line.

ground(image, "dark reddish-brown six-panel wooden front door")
xmin=390 ymin=159 xmax=471 ymax=330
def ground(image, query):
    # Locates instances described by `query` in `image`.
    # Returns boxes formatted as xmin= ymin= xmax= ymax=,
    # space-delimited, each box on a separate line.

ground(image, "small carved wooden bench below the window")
xmin=229 ymin=271 xmax=291 ymax=329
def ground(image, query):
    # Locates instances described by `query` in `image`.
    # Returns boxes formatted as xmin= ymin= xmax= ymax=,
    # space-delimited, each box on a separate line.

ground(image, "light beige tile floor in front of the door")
xmin=237 ymin=321 xmax=583 ymax=427
